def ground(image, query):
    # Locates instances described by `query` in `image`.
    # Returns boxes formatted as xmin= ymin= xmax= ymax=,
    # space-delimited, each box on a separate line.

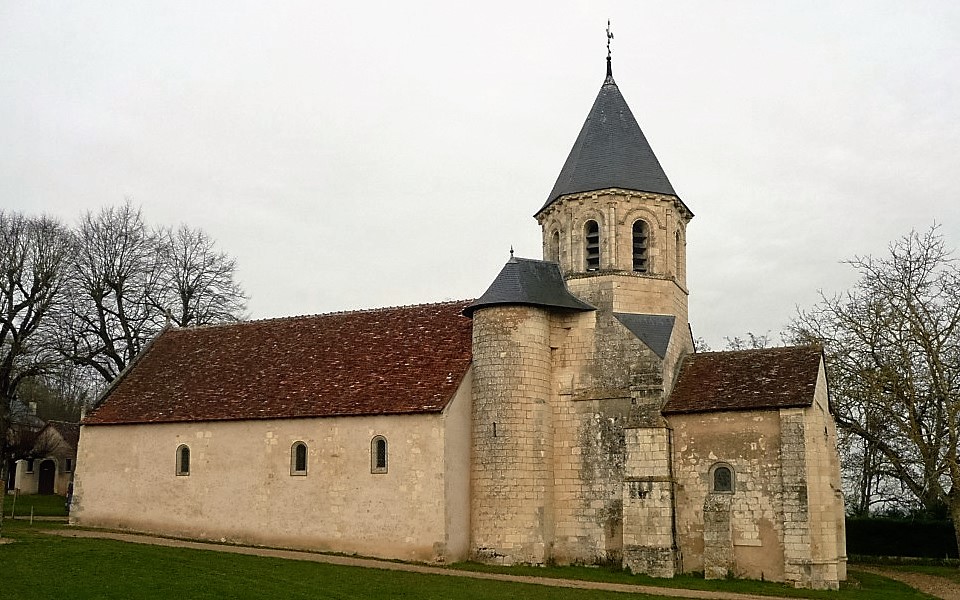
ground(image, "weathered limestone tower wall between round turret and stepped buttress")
xmin=551 ymin=300 xmax=659 ymax=563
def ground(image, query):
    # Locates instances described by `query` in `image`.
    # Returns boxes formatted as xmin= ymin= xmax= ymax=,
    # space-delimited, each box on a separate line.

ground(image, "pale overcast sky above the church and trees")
xmin=0 ymin=0 xmax=960 ymax=348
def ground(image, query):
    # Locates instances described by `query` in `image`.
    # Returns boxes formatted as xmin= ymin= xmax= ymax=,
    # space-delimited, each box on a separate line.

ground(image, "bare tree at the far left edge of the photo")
xmin=0 ymin=211 xmax=70 ymax=488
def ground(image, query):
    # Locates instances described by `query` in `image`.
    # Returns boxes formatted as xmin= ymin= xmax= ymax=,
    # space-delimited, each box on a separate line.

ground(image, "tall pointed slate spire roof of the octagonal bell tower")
xmin=537 ymin=59 xmax=677 ymax=214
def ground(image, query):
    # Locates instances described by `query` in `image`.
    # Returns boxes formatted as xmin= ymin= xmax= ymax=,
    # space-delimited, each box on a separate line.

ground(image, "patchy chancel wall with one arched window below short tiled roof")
xmin=668 ymin=411 xmax=784 ymax=581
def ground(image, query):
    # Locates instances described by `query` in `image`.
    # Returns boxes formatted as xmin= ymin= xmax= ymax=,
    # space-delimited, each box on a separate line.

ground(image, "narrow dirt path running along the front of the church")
xmin=49 ymin=529 xmax=796 ymax=600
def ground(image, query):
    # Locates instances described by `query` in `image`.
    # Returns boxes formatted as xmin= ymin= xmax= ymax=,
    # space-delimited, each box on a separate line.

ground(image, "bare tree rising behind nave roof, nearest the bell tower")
xmin=151 ymin=225 xmax=246 ymax=327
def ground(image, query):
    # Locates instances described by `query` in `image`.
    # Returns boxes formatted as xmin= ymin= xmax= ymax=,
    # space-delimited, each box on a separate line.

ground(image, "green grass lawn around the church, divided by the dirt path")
xmin=0 ymin=521 xmax=929 ymax=600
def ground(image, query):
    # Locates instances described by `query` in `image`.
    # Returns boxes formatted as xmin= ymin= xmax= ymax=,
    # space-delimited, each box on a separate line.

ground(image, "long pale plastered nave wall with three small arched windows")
xmin=71 ymin=380 xmax=470 ymax=561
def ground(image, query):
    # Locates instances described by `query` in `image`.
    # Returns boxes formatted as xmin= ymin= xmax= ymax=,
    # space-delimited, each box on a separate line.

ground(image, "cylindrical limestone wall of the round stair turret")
xmin=471 ymin=306 xmax=555 ymax=564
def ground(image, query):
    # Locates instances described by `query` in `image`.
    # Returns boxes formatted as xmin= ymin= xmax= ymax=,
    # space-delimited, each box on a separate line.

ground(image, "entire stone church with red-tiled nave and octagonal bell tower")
xmin=72 ymin=57 xmax=846 ymax=588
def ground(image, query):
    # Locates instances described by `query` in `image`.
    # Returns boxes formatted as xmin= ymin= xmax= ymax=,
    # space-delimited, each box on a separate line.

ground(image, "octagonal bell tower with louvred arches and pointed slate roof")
xmin=535 ymin=56 xmax=693 ymax=338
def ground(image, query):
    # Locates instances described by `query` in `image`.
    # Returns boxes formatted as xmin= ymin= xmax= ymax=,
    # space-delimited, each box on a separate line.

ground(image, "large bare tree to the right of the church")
xmin=791 ymin=226 xmax=960 ymax=545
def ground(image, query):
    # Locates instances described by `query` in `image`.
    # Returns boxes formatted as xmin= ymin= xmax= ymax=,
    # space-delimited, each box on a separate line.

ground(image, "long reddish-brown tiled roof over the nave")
xmin=83 ymin=301 xmax=472 ymax=425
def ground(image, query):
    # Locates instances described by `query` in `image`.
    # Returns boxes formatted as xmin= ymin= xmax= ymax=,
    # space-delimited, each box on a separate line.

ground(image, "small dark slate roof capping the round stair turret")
xmin=463 ymin=256 xmax=596 ymax=317
